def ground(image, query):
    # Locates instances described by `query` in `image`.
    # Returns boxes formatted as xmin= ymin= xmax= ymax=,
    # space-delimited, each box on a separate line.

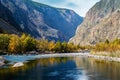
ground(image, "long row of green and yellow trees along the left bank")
xmin=0 ymin=34 xmax=78 ymax=54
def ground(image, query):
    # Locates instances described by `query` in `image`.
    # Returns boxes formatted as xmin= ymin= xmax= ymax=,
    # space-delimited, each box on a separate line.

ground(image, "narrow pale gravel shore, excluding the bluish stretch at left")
xmin=38 ymin=53 xmax=120 ymax=62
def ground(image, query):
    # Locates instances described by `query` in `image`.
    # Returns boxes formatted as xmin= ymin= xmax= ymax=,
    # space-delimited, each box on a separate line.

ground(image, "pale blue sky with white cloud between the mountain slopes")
xmin=33 ymin=0 xmax=99 ymax=17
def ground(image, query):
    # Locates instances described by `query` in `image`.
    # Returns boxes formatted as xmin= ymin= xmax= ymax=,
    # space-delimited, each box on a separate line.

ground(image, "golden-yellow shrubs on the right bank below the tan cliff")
xmin=91 ymin=39 xmax=120 ymax=57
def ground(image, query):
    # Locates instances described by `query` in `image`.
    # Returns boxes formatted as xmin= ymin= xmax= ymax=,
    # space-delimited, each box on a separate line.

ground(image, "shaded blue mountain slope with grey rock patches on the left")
xmin=0 ymin=0 xmax=83 ymax=41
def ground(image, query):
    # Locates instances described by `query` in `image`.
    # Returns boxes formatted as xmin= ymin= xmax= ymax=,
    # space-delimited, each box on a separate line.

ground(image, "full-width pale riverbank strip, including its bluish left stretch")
xmin=0 ymin=52 xmax=120 ymax=66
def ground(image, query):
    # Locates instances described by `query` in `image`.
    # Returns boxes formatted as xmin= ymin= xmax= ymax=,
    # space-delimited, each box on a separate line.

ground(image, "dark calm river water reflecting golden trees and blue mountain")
xmin=0 ymin=56 xmax=120 ymax=80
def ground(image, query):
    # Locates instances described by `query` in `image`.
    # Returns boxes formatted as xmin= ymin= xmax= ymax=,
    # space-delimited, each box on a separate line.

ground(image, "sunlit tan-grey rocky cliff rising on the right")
xmin=70 ymin=0 xmax=120 ymax=45
